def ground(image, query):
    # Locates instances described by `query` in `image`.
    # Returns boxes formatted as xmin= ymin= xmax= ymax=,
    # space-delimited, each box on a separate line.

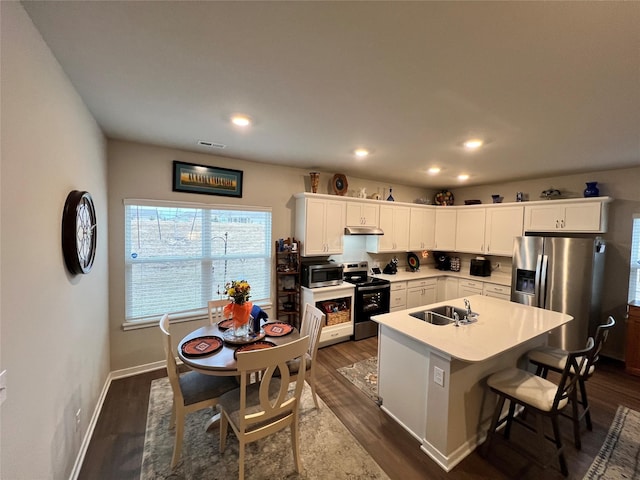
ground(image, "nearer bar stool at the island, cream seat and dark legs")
xmin=483 ymin=338 xmax=594 ymax=476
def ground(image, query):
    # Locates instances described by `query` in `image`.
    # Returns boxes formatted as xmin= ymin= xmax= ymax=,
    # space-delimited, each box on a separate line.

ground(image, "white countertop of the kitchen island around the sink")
xmin=373 ymin=295 xmax=573 ymax=362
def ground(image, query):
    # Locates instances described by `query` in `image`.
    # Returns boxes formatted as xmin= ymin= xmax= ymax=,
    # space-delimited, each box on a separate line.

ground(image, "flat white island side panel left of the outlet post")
xmin=378 ymin=325 xmax=429 ymax=442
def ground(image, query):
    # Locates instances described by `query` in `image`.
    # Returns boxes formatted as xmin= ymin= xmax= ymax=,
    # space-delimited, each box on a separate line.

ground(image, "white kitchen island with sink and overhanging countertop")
xmin=373 ymin=295 xmax=573 ymax=471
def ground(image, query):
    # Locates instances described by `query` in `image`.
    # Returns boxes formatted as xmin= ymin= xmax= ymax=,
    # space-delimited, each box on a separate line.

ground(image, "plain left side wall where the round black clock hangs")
xmin=0 ymin=2 xmax=109 ymax=480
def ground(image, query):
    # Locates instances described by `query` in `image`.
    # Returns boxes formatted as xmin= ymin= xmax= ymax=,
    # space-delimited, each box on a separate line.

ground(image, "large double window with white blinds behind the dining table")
xmin=125 ymin=200 xmax=272 ymax=322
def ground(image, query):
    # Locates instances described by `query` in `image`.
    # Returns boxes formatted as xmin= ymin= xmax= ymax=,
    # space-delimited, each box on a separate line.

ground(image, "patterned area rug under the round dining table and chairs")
xmin=140 ymin=377 xmax=389 ymax=480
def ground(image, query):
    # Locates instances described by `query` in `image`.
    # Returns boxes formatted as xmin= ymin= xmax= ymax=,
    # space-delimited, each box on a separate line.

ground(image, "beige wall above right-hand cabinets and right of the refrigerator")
xmin=454 ymin=167 xmax=640 ymax=360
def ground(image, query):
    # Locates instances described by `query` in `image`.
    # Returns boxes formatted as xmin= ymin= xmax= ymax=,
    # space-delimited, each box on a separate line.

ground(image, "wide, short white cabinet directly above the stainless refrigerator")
xmin=524 ymin=197 xmax=610 ymax=233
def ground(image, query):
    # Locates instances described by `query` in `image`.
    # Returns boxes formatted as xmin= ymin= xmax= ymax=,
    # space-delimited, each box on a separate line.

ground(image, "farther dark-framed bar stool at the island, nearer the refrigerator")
xmin=527 ymin=316 xmax=616 ymax=450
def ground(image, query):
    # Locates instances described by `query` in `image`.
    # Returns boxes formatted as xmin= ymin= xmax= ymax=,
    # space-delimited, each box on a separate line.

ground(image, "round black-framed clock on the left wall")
xmin=62 ymin=190 xmax=98 ymax=274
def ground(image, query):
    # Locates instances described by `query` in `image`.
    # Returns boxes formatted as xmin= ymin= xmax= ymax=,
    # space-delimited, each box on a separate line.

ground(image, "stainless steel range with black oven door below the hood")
xmin=344 ymin=262 xmax=391 ymax=340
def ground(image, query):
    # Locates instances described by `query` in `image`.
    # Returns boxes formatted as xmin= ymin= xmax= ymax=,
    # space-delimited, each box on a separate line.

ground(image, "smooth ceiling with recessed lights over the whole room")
xmin=23 ymin=1 xmax=640 ymax=188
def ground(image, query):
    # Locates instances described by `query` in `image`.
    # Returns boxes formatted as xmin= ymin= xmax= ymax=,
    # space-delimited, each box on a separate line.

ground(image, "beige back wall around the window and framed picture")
xmin=108 ymin=140 xmax=426 ymax=370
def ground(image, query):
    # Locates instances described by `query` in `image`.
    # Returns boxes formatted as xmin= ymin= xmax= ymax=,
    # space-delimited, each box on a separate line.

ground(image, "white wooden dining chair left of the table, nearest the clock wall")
xmin=160 ymin=314 xmax=238 ymax=468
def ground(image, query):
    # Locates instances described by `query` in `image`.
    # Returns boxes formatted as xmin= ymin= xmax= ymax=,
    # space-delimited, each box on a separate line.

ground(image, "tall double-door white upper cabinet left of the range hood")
xmin=295 ymin=196 xmax=346 ymax=256
